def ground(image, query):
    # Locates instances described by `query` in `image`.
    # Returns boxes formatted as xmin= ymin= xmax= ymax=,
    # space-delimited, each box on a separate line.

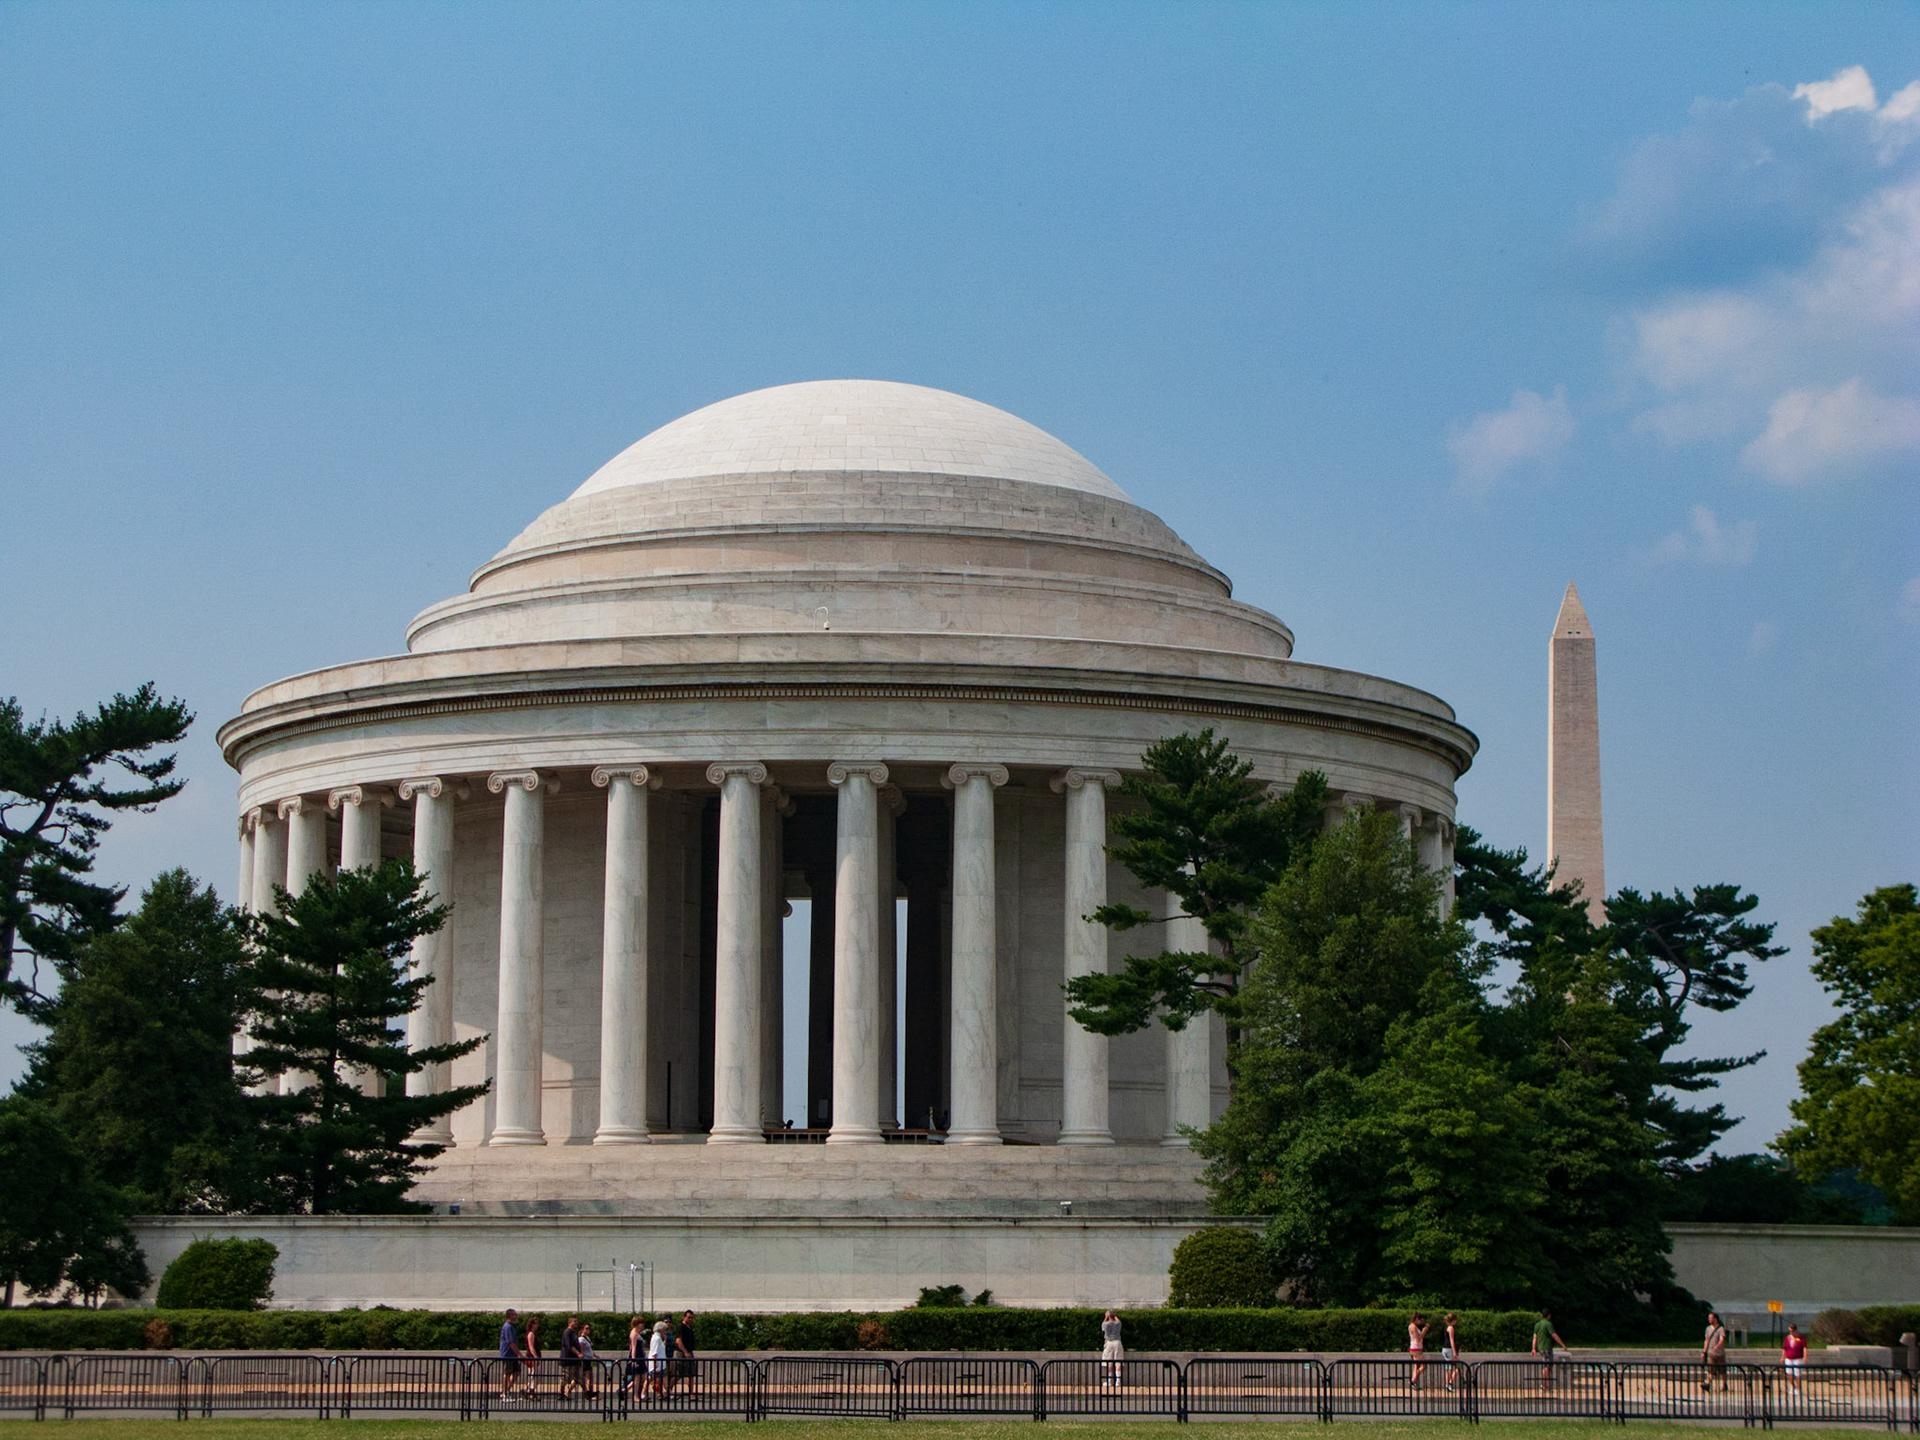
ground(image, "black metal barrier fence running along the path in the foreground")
xmin=0 ymin=1352 xmax=1920 ymax=1434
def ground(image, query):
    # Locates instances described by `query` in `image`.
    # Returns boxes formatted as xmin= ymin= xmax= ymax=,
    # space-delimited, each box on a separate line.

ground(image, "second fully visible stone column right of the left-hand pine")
xmin=593 ymin=764 xmax=660 ymax=1144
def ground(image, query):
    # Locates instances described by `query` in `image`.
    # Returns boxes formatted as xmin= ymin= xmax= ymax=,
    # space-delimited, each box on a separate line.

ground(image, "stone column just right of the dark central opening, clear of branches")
xmin=947 ymin=764 xmax=1006 ymax=1144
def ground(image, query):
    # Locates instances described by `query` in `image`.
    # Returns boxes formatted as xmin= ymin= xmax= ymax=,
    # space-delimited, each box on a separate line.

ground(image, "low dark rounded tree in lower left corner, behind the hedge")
xmin=0 ymin=1096 xmax=150 ymax=1306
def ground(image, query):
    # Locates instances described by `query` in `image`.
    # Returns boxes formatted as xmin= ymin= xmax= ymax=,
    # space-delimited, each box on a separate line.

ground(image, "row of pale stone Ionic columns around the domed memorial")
xmin=240 ymin=760 xmax=1452 ymax=1146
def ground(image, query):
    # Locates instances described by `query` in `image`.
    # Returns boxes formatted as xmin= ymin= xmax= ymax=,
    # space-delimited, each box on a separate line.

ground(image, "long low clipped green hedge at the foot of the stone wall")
xmin=0 ymin=1306 xmax=1536 ymax=1356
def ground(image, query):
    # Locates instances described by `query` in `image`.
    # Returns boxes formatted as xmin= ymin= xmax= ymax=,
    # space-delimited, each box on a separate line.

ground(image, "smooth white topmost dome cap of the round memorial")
xmin=572 ymin=380 xmax=1127 ymax=501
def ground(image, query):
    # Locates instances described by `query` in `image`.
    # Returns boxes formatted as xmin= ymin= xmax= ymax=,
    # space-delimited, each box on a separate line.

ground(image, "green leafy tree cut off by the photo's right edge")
xmin=1776 ymin=885 xmax=1920 ymax=1225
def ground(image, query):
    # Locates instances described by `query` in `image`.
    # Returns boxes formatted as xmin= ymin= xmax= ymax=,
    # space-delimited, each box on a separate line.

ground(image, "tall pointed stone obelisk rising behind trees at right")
xmin=1548 ymin=582 xmax=1607 ymax=924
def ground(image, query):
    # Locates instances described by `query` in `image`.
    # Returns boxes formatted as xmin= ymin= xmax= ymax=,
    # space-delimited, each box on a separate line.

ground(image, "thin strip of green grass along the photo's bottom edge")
xmin=0 ymin=1417 xmax=1880 ymax=1440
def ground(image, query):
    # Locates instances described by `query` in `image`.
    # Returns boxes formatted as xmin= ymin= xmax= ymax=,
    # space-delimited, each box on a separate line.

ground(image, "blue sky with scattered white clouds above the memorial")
xmin=0 ymin=2 xmax=1920 ymax=1148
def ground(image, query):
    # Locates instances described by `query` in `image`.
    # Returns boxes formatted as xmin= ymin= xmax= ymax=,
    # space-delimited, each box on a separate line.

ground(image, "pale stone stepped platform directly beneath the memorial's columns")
xmin=413 ymin=1142 xmax=1206 ymax=1219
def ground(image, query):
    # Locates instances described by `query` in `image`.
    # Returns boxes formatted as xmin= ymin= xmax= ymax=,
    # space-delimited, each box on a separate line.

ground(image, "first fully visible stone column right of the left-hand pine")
xmin=486 ymin=770 xmax=559 ymax=1144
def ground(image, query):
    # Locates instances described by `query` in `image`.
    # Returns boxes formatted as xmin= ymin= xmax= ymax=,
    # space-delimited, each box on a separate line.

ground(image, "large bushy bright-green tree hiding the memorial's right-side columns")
xmin=1194 ymin=814 xmax=1540 ymax=1306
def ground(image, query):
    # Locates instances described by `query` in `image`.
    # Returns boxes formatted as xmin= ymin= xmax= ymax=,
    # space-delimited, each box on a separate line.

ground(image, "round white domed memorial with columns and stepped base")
xmin=206 ymin=380 xmax=1475 ymax=1308
